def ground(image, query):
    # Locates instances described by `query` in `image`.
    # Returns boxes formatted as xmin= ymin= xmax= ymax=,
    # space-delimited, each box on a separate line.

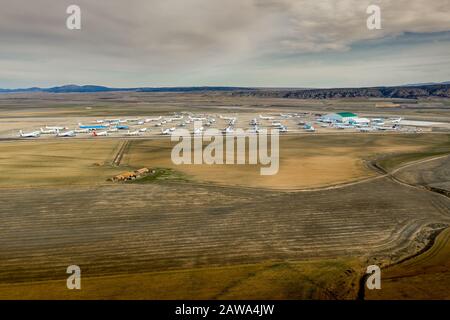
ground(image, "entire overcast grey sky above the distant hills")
xmin=0 ymin=0 xmax=450 ymax=88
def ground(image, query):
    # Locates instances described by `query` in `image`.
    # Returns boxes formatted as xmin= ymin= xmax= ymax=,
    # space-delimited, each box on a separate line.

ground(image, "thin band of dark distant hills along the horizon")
xmin=0 ymin=81 xmax=450 ymax=99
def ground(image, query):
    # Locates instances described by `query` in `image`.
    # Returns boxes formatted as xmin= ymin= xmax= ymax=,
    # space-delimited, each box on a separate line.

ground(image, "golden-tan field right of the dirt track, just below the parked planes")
xmin=123 ymin=134 xmax=450 ymax=189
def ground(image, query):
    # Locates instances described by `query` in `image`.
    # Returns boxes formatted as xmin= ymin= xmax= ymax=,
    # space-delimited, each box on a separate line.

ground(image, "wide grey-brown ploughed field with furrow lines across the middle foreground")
xmin=0 ymin=174 xmax=450 ymax=297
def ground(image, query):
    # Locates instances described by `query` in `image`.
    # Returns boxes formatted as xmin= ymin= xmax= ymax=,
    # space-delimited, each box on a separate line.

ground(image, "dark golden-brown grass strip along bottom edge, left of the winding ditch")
xmin=0 ymin=259 xmax=360 ymax=300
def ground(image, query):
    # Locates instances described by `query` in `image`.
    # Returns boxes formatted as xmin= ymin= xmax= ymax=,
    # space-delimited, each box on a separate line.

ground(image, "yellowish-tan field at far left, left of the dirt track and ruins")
xmin=0 ymin=140 xmax=123 ymax=188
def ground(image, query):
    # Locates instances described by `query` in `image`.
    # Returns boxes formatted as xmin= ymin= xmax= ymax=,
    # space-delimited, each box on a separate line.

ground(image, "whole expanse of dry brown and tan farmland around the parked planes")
xmin=0 ymin=94 xmax=450 ymax=299
